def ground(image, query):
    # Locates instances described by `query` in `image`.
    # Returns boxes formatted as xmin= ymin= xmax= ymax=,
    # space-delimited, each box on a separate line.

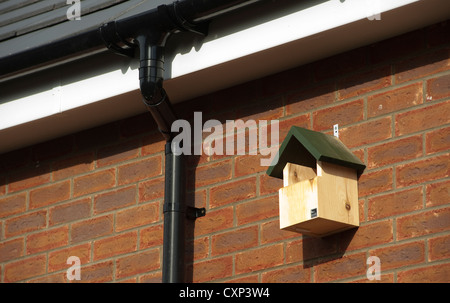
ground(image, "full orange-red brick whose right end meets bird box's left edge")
xmin=236 ymin=195 xmax=279 ymax=225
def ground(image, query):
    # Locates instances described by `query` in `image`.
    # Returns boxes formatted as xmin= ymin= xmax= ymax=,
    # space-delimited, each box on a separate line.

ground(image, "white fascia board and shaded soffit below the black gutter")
xmin=0 ymin=0 xmax=450 ymax=153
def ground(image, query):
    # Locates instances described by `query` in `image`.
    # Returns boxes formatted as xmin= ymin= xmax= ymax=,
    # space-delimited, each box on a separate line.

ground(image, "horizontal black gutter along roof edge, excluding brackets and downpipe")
xmin=0 ymin=0 xmax=260 ymax=82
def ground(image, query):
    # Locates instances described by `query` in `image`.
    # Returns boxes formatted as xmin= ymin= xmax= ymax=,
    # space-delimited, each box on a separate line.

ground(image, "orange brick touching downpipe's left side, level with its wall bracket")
xmin=115 ymin=202 xmax=159 ymax=232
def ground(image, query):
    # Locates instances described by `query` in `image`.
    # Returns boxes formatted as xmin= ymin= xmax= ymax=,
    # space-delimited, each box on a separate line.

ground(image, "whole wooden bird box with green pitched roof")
xmin=267 ymin=126 xmax=366 ymax=237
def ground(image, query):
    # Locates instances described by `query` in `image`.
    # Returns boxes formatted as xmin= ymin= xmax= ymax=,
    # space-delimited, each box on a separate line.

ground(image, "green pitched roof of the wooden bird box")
xmin=266 ymin=126 xmax=366 ymax=179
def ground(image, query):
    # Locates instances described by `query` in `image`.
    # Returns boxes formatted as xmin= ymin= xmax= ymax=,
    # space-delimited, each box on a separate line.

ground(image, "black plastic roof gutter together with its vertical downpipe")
xmin=0 ymin=0 xmax=259 ymax=283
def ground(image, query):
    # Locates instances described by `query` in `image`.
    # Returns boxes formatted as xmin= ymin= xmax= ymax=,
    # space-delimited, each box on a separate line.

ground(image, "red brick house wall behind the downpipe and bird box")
xmin=0 ymin=22 xmax=450 ymax=282
